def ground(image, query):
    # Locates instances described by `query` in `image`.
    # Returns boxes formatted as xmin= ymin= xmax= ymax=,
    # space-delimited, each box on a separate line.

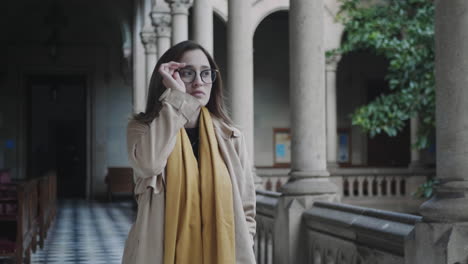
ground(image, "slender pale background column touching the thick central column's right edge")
xmin=326 ymin=56 xmax=341 ymax=168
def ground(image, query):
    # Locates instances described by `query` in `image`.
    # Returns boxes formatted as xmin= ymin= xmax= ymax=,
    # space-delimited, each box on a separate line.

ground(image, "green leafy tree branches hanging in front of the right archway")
xmin=327 ymin=0 xmax=435 ymax=149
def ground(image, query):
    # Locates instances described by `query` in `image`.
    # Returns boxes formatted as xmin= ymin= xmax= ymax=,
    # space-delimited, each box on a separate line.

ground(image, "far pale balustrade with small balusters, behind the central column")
xmin=257 ymin=168 xmax=435 ymax=213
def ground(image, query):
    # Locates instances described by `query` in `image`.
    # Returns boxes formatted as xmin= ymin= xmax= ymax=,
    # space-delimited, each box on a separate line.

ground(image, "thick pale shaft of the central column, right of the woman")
xmin=289 ymin=0 xmax=328 ymax=177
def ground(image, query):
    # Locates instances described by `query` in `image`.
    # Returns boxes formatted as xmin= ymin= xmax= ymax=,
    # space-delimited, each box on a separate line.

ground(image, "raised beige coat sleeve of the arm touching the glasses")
xmin=127 ymin=89 xmax=201 ymax=192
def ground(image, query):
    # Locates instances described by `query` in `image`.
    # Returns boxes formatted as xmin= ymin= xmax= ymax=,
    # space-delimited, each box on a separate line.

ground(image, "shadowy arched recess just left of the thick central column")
xmin=253 ymin=11 xmax=290 ymax=167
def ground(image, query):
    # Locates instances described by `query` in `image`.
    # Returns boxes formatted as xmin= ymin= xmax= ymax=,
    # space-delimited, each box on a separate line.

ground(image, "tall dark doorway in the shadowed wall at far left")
xmin=27 ymin=75 xmax=86 ymax=198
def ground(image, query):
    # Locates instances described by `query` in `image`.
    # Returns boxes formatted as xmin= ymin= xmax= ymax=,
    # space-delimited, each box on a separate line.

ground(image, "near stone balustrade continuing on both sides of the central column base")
xmin=255 ymin=191 xmax=421 ymax=264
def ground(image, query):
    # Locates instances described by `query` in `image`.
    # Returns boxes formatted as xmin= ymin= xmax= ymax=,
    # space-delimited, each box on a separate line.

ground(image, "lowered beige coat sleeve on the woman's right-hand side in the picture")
xmin=238 ymin=135 xmax=256 ymax=245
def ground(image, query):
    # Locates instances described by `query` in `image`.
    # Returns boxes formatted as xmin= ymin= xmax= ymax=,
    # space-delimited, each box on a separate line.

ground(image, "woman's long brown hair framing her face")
xmin=133 ymin=40 xmax=232 ymax=124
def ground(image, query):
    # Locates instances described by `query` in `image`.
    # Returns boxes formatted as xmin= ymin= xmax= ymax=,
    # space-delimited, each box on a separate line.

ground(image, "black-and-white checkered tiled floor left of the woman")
xmin=31 ymin=200 xmax=134 ymax=264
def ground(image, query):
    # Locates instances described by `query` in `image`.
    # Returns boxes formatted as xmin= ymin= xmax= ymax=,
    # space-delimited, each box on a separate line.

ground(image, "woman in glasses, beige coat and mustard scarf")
xmin=123 ymin=41 xmax=255 ymax=264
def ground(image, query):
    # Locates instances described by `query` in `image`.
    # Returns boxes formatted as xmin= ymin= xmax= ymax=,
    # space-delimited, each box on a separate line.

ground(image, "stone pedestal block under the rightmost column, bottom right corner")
xmin=405 ymin=222 xmax=468 ymax=264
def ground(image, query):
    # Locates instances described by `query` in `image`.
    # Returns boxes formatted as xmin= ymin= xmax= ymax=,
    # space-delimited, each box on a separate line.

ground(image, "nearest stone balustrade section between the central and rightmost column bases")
xmin=302 ymin=202 xmax=421 ymax=264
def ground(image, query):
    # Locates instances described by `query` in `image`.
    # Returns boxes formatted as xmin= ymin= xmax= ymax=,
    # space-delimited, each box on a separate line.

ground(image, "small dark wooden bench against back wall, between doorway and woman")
xmin=105 ymin=167 xmax=134 ymax=201
